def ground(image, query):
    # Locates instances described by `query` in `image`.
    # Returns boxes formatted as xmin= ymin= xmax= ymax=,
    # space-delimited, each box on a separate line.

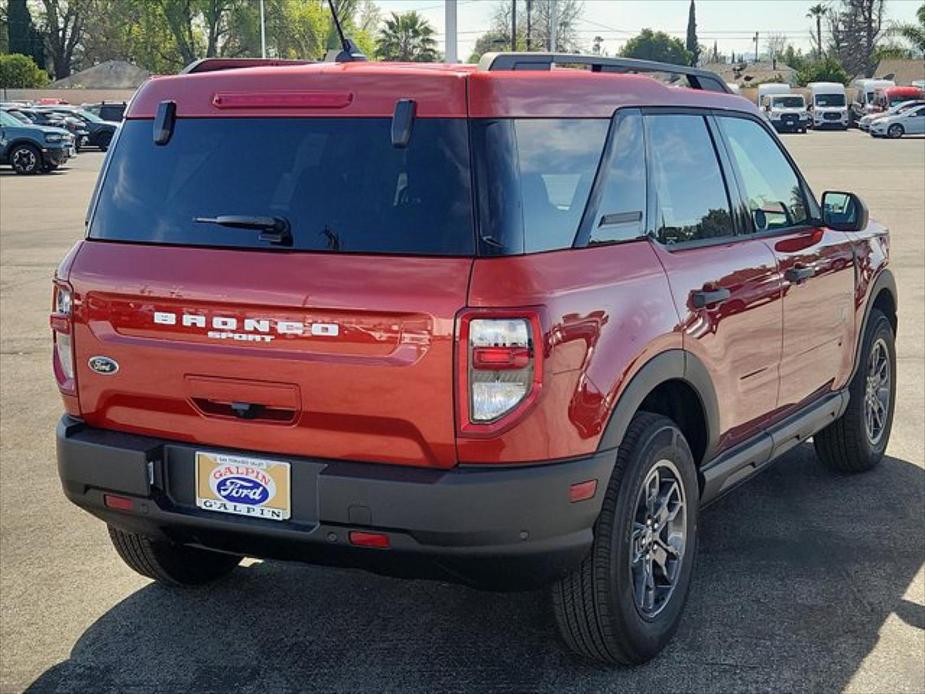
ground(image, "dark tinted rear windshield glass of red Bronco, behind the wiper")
xmin=90 ymin=118 xmax=475 ymax=255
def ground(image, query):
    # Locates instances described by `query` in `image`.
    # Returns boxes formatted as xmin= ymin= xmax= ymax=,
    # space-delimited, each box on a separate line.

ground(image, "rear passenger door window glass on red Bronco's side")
xmin=646 ymin=114 xmax=734 ymax=244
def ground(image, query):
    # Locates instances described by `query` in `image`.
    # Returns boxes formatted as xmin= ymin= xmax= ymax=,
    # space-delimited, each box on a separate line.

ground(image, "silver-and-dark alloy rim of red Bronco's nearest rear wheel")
xmin=629 ymin=460 xmax=687 ymax=619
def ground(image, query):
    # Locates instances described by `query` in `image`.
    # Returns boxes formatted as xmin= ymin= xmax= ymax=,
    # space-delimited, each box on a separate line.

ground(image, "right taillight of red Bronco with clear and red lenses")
xmin=457 ymin=311 xmax=543 ymax=435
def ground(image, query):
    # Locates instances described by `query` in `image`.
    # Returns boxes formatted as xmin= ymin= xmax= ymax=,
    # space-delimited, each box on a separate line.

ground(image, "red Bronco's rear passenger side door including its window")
xmin=646 ymin=112 xmax=782 ymax=454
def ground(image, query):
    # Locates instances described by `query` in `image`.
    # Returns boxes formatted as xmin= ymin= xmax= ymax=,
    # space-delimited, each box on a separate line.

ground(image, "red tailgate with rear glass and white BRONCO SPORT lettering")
xmin=69 ymin=118 xmax=474 ymax=467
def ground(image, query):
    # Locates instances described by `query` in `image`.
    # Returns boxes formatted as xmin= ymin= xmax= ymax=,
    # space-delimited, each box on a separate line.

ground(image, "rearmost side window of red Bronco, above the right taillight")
xmin=514 ymin=119 xmax=610 ymax=253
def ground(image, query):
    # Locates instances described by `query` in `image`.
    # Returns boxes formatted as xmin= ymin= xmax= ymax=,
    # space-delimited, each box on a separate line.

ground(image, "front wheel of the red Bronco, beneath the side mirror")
xmin=813 ymin=308 xmax=896 ymax=472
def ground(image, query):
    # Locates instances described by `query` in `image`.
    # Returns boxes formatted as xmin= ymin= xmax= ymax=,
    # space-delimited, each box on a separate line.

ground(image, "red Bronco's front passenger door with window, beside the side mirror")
xmin=717 ymin=115 xmax=855 ymax=410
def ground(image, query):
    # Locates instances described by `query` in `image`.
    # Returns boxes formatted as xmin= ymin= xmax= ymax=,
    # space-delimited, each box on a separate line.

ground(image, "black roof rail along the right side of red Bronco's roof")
xmin=479 ymin=53 xmax=732 ymax=94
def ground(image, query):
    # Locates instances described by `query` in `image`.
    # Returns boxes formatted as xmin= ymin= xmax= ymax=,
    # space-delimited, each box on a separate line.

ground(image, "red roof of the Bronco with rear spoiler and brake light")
xmin=127 ymin=62 xmax=754 ymax=118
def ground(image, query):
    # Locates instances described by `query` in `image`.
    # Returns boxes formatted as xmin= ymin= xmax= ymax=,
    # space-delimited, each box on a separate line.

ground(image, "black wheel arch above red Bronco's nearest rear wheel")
xmin=598 ymin=349 xmax=720 ymax=467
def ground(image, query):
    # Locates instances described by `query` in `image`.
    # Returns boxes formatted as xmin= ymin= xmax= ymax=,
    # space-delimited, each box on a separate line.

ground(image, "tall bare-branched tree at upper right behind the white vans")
xmin=827 ymin=0 xmax=886 ymax=77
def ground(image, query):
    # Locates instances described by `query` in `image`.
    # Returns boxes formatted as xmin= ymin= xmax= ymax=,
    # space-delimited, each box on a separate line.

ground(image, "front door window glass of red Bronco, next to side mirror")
xmin=717 ymin=117 xmax=809 ymax=232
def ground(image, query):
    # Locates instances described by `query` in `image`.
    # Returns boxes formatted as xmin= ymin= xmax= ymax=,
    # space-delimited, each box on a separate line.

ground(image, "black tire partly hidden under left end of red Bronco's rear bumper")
xmin=109 ymin=526 xmax=241 ymax=587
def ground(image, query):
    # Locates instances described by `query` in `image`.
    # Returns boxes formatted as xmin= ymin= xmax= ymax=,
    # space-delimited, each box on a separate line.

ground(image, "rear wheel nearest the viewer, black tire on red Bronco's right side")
xmin=552 ymin=412 xmax=700 ymax=665
